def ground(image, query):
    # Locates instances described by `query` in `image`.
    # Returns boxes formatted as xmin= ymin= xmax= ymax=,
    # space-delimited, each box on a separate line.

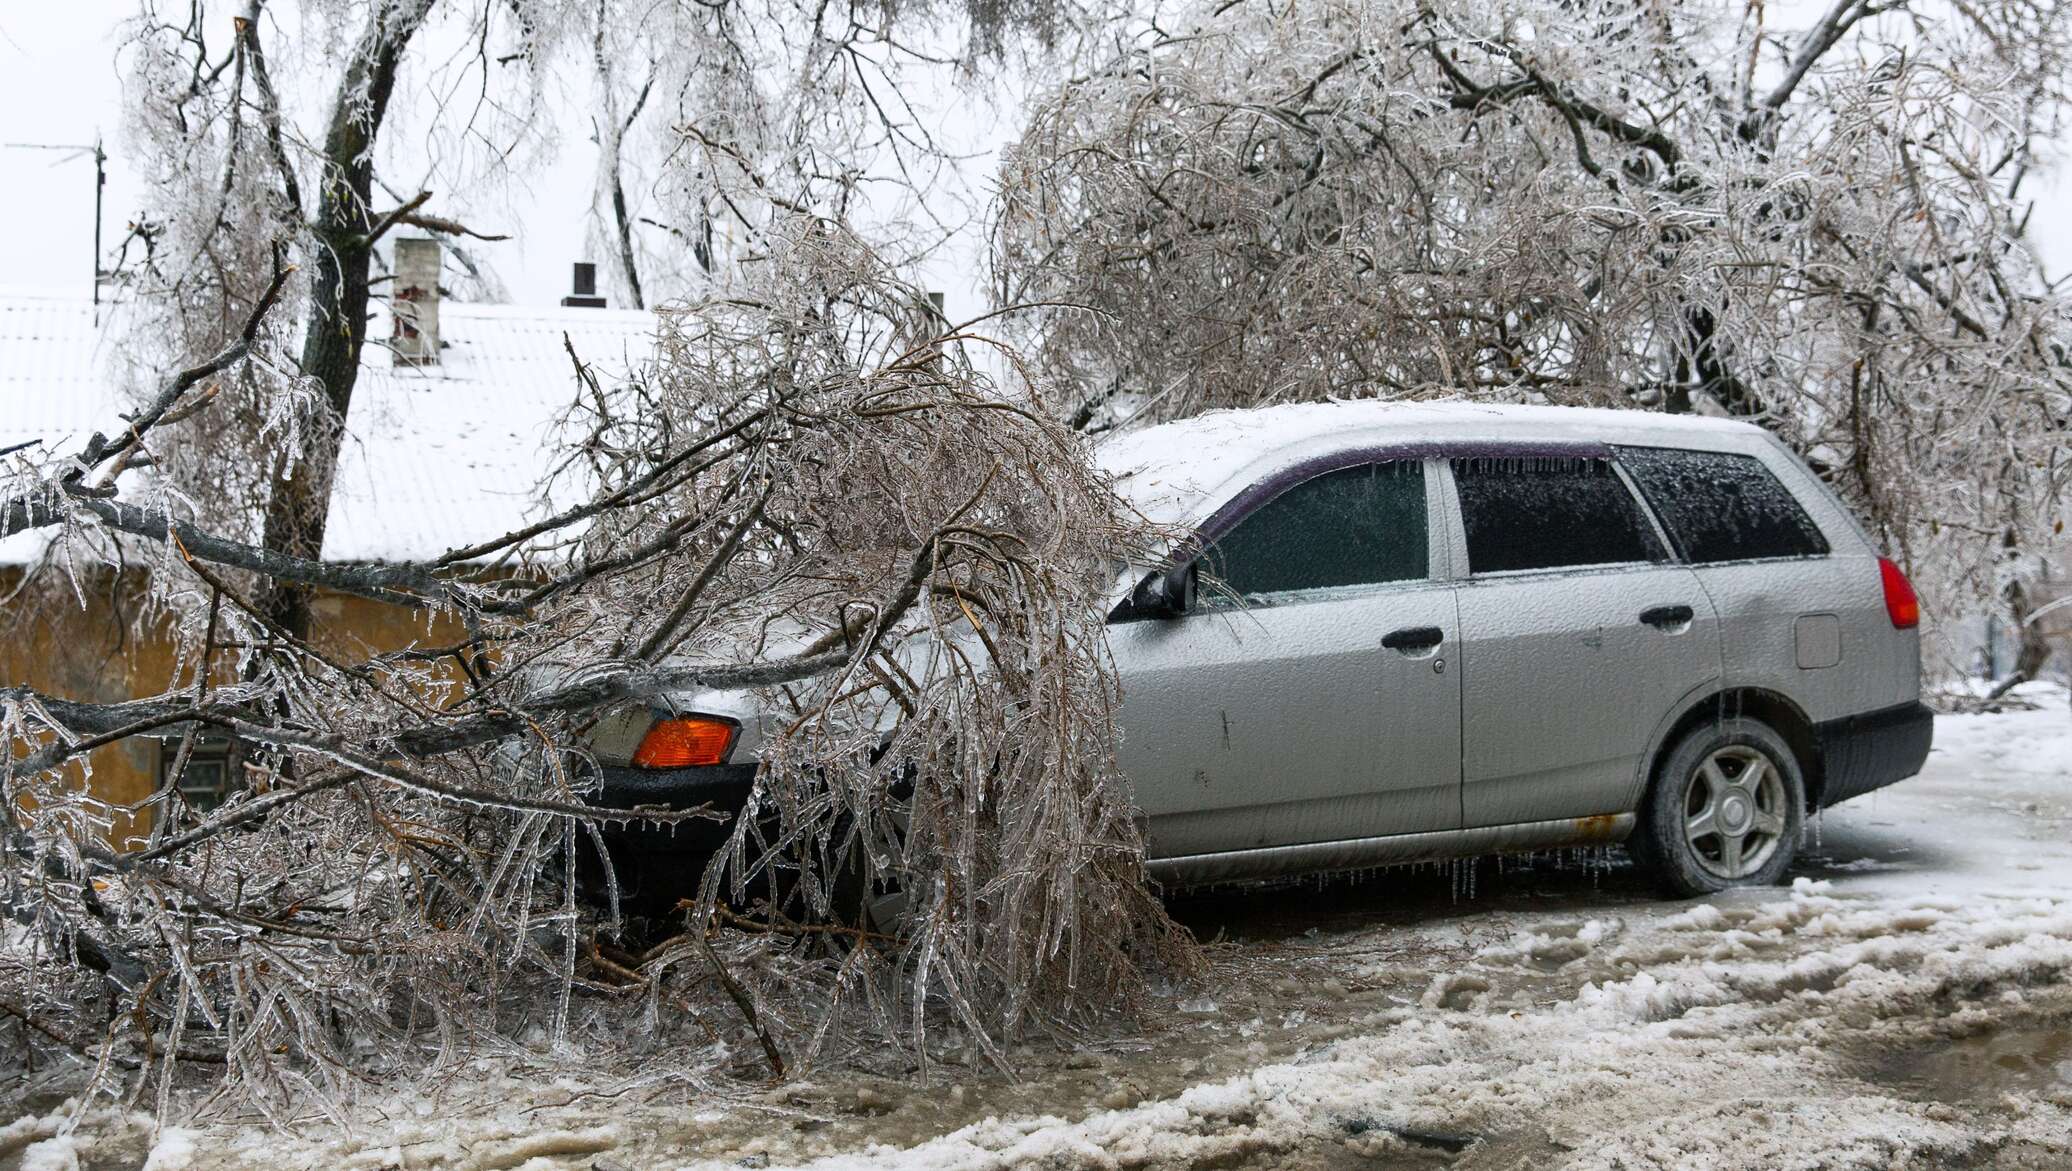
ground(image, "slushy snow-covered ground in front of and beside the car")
xmin=16 ymin=688 xmax=2072 ymax=1171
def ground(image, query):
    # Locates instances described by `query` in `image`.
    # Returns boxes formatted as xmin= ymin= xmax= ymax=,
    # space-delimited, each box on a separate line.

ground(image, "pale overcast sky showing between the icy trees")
xmin=0 ymin=0 xmax=2072 ymax=319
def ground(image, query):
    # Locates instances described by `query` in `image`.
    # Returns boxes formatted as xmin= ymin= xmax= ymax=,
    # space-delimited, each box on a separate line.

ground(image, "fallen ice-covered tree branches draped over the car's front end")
xmin=0 ymin=220 xmax=1191 ymax=1105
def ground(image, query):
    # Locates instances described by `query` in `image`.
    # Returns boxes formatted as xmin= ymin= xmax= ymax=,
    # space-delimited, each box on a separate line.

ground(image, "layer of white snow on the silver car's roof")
xmin=1094 ymin=400 xmax=1761 ymax=524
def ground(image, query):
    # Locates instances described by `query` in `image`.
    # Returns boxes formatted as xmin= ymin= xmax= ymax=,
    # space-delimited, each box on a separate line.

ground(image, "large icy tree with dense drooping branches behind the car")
xmin=995 ymin=0 xmax=2072 ymax=638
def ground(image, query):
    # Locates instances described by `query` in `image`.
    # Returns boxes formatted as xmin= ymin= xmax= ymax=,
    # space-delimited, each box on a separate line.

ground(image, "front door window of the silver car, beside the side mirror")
xmin=1202 ymin=460 xmax=1428 ymax=601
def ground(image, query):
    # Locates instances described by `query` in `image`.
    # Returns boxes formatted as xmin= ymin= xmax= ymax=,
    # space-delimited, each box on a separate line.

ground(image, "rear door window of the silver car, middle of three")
xmin=1452 ymin=456 xmax=1662 ymax=574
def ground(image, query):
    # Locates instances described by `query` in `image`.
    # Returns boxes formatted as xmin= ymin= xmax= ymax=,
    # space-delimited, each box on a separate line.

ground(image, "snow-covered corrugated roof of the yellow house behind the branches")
xmin=0 ymin=290 xmax=655 ymax=564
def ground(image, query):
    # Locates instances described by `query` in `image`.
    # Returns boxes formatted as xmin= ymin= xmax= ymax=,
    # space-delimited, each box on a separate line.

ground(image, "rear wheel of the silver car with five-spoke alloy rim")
xmin=1631 ymin=717 xmax=1807 ymax=897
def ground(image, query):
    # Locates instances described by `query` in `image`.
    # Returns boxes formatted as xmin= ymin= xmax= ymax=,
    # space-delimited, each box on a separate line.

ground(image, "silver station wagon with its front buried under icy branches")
xmin=595 ymin=402 xmax=1931 ymax=895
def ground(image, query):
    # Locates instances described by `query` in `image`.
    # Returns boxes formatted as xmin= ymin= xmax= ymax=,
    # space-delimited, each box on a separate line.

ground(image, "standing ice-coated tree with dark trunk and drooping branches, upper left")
xmin=113 ymin=0 xmax=1094 ymax=636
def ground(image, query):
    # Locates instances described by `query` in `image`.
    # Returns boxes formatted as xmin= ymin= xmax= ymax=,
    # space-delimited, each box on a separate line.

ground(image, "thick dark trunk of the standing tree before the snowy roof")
xmin=259 ymin=0 xmax=433 ymax=638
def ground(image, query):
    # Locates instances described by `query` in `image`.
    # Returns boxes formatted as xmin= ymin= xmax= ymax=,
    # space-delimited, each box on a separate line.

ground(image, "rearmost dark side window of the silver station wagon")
xmin=1618 ymin=448 xmax=1828 ymax=564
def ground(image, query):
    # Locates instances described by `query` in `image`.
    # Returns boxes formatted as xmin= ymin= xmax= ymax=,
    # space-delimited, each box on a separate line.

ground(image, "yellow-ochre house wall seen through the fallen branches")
xmin=0 ymin=566 xmax=464 ymax=846
